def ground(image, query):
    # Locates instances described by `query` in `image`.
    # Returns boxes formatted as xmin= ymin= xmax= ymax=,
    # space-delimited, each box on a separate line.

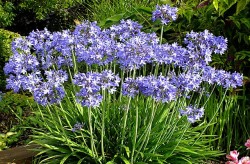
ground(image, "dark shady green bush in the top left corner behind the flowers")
xmin=0 ymin=0 xmax=87 ymax=35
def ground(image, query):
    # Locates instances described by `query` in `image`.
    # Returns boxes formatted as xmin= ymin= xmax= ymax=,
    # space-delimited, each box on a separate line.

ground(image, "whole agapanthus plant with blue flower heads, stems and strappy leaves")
xmin=4 ymin=5 xmax=242 ymax=163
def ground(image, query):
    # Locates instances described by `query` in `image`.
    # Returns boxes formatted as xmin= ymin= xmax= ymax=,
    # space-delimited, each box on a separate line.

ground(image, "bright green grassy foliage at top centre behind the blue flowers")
xmin=88 ymin=0 xmax=160 ymax=25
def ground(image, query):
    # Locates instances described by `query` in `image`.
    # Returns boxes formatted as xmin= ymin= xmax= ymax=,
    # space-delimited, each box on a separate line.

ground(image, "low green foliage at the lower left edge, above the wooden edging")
xmin=0 ymin=92 xmax=35 ymax=147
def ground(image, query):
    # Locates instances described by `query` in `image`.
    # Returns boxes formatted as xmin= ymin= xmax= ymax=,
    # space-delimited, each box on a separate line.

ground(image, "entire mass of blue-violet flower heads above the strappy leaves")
xmin=4 ymin=5 xmax=243 ymax=107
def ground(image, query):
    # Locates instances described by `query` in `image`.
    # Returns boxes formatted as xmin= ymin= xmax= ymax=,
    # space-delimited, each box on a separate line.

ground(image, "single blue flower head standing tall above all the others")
xmin=152 ymin=5 xmax=178 ymax=25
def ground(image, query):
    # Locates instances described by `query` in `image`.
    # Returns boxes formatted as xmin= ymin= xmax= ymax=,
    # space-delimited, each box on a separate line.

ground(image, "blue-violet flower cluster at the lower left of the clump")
xmin=6 ymin=66 xmax=68 ymax=106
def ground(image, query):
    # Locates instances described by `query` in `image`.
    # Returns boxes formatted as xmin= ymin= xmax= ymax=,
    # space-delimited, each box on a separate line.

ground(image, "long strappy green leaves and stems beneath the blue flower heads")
xmin=32 ymin=93 xmax=221 ymax=164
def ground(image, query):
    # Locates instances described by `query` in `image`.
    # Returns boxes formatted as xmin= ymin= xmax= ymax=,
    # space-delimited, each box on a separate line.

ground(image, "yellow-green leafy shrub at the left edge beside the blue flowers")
xmin=0 ymin=29 xmax=20 ymax=91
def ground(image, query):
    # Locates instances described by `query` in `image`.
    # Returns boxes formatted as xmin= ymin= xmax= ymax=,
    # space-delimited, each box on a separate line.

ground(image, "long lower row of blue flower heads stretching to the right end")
xmin=122 ymin=66 xmax=243 ymax=103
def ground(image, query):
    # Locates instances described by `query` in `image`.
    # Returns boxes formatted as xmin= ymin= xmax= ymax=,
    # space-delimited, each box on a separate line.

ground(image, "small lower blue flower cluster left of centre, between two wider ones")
xmin=73 ymin=70 xmax=120 ymax=107
